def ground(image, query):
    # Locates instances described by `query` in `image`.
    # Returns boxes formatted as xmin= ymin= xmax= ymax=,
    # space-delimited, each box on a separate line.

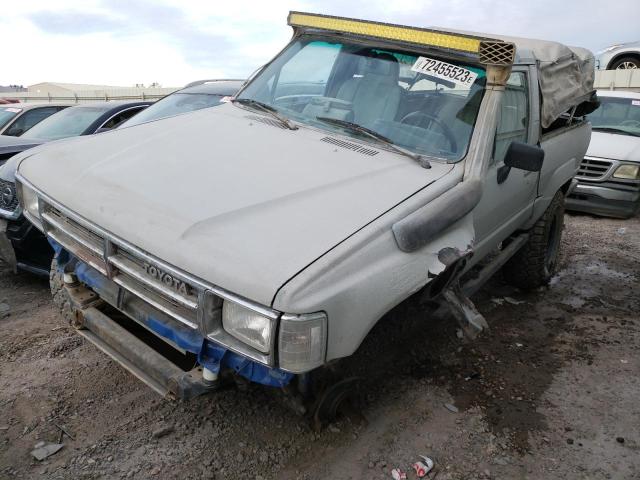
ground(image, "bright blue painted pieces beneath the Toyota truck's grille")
xmin=49 ymin=239 xmax=293 ymax=387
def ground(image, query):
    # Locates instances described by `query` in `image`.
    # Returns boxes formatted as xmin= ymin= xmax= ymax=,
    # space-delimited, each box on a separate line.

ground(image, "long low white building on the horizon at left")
xmin=1 ymin=82 xmax=177 ymax=103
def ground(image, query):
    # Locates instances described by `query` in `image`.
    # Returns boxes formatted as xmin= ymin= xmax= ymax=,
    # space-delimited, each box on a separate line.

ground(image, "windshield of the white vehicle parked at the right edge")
xmin=587 ymin=96 xmax=640 ymax=136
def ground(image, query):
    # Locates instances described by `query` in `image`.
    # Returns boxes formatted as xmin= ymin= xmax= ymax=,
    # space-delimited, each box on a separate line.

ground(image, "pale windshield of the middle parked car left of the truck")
xmin=22 ymin=106 xmax=111 ymax=140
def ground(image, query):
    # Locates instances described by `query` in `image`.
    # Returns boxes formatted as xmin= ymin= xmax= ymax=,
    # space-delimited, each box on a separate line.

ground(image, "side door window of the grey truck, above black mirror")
xmin=493 ymin=72 xmax=529 ymax=163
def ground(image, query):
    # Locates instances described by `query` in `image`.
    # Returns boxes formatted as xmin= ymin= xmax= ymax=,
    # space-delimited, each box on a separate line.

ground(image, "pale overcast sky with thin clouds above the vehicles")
xmin=0 ymin=0 xmax=640 ymax=86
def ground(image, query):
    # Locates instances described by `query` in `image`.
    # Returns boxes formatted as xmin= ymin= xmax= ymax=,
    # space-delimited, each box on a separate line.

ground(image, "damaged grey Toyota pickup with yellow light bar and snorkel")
xmin=16 ymin=12 xmax=595 ymax=420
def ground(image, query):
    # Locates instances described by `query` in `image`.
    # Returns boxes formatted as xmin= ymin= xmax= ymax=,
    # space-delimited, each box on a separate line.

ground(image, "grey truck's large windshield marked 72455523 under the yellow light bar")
xmin=238 ymin=36 xmax=486 ymax=161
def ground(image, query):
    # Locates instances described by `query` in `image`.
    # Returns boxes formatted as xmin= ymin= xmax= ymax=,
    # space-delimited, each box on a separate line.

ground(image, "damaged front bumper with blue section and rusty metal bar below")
xmin=52 ymin=246 xmax=294 ymax=399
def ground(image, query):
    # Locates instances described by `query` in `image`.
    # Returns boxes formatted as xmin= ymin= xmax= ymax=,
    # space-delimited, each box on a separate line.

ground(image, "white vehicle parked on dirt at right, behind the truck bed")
xmin=567 ymin=90 xmax=640 ymax=218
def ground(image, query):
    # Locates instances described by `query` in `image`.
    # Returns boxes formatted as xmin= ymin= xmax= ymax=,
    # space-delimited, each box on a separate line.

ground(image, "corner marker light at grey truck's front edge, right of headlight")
xmin=278 ymin=312 xmax=327 ymax=373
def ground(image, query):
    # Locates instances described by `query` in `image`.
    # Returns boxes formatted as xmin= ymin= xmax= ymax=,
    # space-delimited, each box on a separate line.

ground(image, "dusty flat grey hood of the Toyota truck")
xmin=19 ymin=104 xmax=452 ymax=313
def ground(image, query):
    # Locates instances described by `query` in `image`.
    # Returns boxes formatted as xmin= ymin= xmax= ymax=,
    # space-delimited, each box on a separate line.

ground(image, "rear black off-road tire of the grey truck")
xmin=503 ymin=191 xmax=564 ymax=290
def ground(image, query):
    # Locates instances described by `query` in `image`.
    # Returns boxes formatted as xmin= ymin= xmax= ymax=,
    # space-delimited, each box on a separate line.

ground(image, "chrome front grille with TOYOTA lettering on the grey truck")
xmin=42 ymin=202 xmax=210 ymax=329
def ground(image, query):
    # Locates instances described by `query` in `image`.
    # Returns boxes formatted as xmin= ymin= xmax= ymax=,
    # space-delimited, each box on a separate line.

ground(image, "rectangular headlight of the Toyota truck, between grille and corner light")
xmin=222 ymin=301 xmax=275 ymax=353
